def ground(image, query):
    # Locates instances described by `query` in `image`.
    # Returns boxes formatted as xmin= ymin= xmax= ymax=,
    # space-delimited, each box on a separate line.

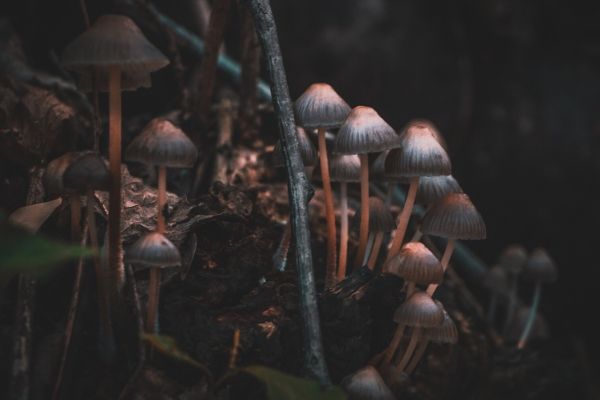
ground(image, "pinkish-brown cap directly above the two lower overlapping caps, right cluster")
xmin=383 ymin=242 xmax=444 ymax=285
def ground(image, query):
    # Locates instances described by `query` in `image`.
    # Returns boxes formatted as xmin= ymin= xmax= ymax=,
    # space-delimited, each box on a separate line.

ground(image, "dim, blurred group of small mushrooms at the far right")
xmin=483 ymin=244 xmax=558 ymax=349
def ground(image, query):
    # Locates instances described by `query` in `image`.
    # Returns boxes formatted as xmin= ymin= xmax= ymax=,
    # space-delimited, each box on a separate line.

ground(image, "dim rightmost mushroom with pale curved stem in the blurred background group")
xmin=517 ymin=248 xmax=558 ymax=349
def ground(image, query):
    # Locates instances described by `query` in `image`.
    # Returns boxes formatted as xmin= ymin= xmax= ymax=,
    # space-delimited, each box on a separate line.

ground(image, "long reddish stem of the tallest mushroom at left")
xmin=108 ymin=66 xmax=123 ymax=299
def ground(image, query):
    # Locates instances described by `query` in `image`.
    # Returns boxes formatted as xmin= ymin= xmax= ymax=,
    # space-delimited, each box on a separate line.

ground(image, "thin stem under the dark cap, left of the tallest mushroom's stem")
xmin=86 ymin=189 xmax=114 ymax=354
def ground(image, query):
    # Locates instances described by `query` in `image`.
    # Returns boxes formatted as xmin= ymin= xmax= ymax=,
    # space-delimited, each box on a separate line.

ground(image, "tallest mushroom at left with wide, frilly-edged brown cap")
xmin=62 ymin=15 xmax=169 ymax=295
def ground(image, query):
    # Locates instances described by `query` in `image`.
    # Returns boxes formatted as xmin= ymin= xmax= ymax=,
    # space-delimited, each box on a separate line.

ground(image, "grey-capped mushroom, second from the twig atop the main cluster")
xmin=333 ymin=106 xmax=398 ymax=267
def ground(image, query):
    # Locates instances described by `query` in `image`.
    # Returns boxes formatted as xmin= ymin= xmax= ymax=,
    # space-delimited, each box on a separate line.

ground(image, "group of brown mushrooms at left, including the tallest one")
xmin=44 ymin=15 xmax=197 ymax=358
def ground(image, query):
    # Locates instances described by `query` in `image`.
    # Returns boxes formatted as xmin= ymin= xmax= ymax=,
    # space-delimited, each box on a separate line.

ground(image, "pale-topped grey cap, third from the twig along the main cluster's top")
xmin=385 ymin=122 xmax=452 ymax=178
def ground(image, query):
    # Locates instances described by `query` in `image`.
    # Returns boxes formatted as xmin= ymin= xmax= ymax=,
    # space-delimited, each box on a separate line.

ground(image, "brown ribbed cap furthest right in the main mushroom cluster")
xmin=421 ymin=193 xmax=486 ymax=239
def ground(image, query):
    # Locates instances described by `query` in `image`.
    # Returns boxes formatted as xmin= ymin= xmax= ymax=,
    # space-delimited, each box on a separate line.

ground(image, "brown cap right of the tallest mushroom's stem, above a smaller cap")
xmin=126 ymin=118 xmax=198 ymax=168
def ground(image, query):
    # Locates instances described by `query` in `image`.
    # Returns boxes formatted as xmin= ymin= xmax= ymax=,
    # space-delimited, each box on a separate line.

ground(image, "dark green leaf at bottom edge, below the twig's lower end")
xmin=241 ymin=365 xmax=347 ymax=400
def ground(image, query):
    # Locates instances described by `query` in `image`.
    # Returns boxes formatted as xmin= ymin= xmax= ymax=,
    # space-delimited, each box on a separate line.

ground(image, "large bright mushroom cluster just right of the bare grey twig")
xmin=275 ymin=83 xmax=486 ymax=390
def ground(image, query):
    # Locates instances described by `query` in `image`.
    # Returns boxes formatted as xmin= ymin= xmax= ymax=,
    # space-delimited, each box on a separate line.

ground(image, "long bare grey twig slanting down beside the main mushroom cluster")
xmin=245 ymin=0 xmax=330 ymax=385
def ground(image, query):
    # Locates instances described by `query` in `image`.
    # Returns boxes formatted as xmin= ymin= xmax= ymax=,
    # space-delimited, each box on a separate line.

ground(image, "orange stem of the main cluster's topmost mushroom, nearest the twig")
xmin=318 ymin=128 xmax=337 ymax=287
